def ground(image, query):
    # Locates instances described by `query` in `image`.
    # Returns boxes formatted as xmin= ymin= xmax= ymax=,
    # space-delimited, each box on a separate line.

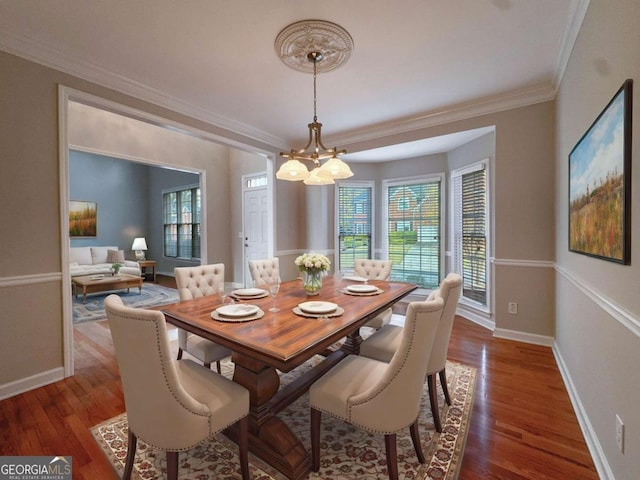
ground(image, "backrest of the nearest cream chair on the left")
xmin=104 ymin=295 xmax=211 ymax=451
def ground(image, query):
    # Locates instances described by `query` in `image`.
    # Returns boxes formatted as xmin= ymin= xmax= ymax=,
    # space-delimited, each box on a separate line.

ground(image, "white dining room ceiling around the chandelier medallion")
xmin=0 ymin=0 xmax=588 ymax=161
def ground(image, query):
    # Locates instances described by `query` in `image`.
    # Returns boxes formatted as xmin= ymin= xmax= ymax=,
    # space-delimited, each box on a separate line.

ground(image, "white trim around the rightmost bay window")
xmin=449 ymin=158 xmax=493 ymax=314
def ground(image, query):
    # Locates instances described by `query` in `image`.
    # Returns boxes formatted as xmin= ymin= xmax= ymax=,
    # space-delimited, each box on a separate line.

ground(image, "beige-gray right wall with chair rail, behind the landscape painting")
xmin=550 ymin=0 xmax=640 ymax=479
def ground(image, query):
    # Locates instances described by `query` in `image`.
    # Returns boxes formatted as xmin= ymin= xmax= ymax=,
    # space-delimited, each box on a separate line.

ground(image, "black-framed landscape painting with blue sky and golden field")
xmin=569 ymin=80 xmax=633 ymax=265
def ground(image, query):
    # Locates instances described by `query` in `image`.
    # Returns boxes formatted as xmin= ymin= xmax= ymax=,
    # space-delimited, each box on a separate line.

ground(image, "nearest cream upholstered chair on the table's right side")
xmin=309 ymin=297 xmax=444 ymax=479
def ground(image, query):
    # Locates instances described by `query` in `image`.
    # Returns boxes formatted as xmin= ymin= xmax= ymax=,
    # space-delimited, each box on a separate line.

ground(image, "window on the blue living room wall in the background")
xmin=162 ymin=187 xmax=200 ymax=259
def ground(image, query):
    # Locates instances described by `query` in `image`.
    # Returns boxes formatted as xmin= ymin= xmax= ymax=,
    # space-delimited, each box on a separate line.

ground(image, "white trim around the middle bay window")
xmin=380 ymin=172 xmax=447 ymax=296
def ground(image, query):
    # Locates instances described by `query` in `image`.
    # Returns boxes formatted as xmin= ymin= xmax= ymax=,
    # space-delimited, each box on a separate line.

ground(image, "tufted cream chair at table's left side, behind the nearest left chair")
xmin=173 ymin=263 xmax=231 ymax=373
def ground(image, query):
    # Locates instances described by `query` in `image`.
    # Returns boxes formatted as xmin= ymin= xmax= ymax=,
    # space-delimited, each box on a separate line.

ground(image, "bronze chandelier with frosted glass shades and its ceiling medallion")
xmin=275 ymin=20 xmax=353 ymax=185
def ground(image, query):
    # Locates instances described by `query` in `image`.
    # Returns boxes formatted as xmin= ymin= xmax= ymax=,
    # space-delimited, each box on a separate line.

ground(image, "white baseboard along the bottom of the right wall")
xmin=552 ymin=342 xmax=615 ymax=480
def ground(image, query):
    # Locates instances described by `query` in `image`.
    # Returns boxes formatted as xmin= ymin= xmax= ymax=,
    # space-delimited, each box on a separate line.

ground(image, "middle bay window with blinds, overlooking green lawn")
xmin=383 ymin=176 xmax=443 ymax=289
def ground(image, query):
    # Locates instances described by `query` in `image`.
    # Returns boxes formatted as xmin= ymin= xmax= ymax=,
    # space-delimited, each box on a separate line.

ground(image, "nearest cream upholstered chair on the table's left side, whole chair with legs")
xmin=104 ymin=295 xmax=249 ymax=480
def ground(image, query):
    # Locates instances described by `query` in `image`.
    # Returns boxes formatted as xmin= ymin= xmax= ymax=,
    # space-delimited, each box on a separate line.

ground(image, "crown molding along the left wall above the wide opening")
xmin=0 ymin=26 xmax=286 ymax=146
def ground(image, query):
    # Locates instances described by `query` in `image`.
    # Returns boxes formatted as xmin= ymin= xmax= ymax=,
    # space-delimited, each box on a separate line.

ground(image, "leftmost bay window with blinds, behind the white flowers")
xmin=336 ymin=182 xmax=373 ymax=271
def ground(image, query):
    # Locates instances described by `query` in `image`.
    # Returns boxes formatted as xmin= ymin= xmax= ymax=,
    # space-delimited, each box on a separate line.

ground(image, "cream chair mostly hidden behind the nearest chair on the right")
xmin=360 ymin=273 xmax=462 ymax=432
